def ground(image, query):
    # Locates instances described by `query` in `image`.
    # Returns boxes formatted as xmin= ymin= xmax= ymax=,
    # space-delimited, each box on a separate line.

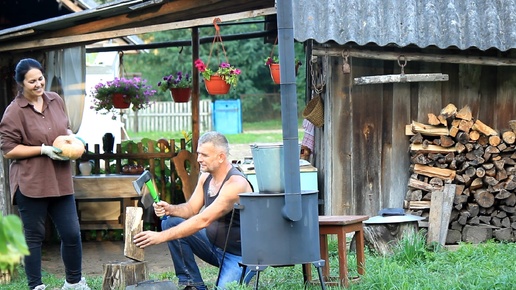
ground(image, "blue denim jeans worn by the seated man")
xmin=161 ymin=217 xmax=254 ymax=289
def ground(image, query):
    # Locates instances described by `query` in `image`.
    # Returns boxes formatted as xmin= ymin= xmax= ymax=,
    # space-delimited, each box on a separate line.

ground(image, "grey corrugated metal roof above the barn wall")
xmin=292 ymin=0 xmax=516 ymax=51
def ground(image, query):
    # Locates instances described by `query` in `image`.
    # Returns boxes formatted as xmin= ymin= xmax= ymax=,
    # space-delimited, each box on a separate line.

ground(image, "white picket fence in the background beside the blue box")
xmin=125 ymin=100 xmax=212 ymax=132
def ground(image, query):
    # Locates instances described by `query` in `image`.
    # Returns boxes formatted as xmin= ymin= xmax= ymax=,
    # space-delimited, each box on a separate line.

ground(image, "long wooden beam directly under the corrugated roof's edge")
xmin=312 ymin=47 xmax=516 ymax=66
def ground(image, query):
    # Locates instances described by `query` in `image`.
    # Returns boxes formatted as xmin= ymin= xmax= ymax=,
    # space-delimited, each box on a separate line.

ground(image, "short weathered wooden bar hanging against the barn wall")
xmin=353 ymin=73 xmax=449 ymax=85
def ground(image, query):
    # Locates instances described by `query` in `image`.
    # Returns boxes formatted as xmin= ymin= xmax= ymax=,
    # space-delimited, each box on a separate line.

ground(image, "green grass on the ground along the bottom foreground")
xmin=7 ymin=233 xmax=516 ymax=290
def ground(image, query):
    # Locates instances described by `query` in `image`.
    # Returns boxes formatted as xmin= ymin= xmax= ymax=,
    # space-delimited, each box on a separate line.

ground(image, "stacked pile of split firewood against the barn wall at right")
xmin=404 ymin=104 xmax=516 ymax=244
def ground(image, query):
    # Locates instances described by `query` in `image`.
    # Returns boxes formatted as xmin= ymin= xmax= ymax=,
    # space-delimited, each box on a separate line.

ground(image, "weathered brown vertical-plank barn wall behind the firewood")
xmin=316 ymin=51 xmax=516 ymax=216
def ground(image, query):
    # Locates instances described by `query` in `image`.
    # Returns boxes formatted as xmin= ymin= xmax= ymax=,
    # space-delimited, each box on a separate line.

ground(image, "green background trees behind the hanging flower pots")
xmin=118 ymin=18 xmax=306 ymax=121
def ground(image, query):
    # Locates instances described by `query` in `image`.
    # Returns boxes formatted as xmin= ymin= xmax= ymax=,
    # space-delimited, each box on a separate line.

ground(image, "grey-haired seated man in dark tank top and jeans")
xmin=134 ymin=132 xmax=253 ymax=289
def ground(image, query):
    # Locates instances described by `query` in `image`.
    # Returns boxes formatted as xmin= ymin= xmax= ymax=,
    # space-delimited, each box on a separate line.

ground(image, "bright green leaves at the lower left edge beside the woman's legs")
xmin=0 ymin=215 xmax=29 ymax=272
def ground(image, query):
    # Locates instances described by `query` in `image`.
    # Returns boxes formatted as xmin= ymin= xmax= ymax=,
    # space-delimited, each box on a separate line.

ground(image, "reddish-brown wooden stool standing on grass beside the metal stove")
xmin=303 ymin=215 xmax=369 ymax=287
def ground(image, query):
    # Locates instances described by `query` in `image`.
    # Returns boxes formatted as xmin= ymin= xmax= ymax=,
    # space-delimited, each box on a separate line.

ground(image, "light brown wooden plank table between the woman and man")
xmin=73 ymin=174 xmax=140 ymax=230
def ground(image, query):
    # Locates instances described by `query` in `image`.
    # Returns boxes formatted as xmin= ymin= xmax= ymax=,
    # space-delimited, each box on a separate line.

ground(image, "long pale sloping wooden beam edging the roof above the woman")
xmin=0 ymin=8 xmax=276 ymax=52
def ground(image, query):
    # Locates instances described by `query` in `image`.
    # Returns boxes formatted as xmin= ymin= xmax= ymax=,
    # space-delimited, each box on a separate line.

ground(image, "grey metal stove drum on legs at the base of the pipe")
xmin=236 ymin=191 xmax=320 ymax=266
